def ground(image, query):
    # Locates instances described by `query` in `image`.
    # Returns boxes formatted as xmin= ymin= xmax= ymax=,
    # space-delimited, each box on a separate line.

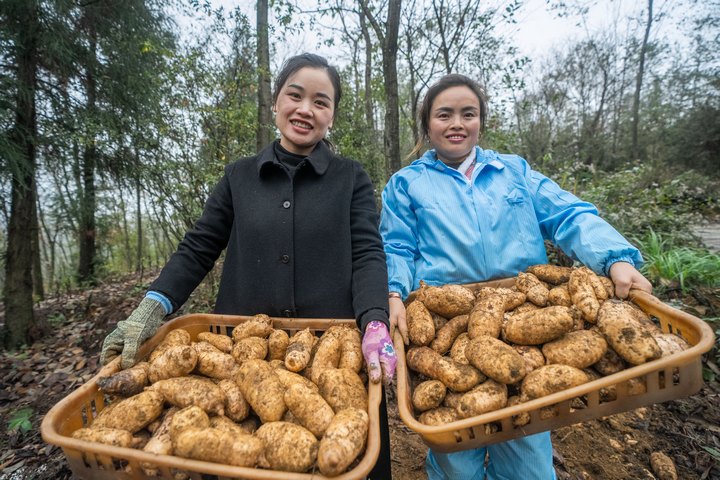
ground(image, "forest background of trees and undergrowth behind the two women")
xmin=0 ymin=0 xmax=720 ymax=351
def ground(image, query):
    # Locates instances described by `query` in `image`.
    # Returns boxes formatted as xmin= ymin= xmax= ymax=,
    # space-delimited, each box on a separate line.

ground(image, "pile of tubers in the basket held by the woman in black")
xmin=77 ymin=314 xmax=369 ymax=480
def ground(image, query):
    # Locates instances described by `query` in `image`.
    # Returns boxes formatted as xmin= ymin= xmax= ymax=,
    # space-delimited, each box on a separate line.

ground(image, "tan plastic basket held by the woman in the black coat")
xmin=40 ymin=314 xmax=382 ymax=480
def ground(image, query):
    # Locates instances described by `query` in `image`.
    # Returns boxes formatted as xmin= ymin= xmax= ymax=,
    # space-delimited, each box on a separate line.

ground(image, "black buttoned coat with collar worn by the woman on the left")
xmin=150 ymin=142 xmax=388 ymax=326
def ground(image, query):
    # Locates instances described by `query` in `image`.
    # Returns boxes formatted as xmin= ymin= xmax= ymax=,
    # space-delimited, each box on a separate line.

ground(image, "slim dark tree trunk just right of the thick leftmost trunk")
xmin=78 ymin=23 xmax=97 ymax=284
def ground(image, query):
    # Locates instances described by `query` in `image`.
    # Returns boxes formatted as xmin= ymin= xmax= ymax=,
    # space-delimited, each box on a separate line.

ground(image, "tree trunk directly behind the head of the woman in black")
xmin=256 ymin=0 xmax=273 ymax=151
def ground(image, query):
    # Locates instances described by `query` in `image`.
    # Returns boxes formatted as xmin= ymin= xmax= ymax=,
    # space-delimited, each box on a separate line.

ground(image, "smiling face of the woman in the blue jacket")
xmin=428 ymin=86 xmax=480 ymax=163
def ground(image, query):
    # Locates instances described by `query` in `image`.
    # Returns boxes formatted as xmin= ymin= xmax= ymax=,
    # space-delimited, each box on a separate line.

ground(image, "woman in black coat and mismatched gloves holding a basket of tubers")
xmin=101 ymin=53 xmax=396 ymax=478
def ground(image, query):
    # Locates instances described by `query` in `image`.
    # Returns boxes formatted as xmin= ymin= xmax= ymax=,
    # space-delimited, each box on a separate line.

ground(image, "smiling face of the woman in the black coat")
xmin=274 ymin=67 xmax=335 ymax=155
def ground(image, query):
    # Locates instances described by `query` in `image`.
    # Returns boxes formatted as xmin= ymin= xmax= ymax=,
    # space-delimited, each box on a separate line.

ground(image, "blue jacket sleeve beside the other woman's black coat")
xmin=380 ymin=177 xmax=418 ymax=299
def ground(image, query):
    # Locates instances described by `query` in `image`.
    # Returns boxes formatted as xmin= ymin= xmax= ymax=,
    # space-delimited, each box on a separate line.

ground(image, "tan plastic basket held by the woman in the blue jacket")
xmin=394 ymin=288 xmax=715 ymax=453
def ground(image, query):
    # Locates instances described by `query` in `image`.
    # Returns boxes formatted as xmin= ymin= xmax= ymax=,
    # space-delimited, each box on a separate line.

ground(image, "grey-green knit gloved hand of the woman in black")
xmin=100 ymin=297 xmax=166 ymax=369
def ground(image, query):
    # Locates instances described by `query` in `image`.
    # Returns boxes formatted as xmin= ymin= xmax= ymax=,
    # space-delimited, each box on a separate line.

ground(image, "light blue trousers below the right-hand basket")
xmin=425 ymin=432 xmax=557 ymax=480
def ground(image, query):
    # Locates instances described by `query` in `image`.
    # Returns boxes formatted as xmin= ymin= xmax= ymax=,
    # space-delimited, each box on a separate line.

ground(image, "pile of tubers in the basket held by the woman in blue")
xmin=406 ymin=265 xmax=689 ymax=428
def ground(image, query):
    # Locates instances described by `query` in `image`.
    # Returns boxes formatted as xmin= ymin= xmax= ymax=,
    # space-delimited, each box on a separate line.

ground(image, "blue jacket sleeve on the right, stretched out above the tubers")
xmin=525 ymin=163 xmax=642 ymax=275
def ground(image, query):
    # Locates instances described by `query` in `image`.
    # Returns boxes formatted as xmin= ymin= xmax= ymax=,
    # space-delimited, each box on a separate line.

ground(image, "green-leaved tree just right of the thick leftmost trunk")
xmin=74 ymin=0 xmax=174 ymax=283
